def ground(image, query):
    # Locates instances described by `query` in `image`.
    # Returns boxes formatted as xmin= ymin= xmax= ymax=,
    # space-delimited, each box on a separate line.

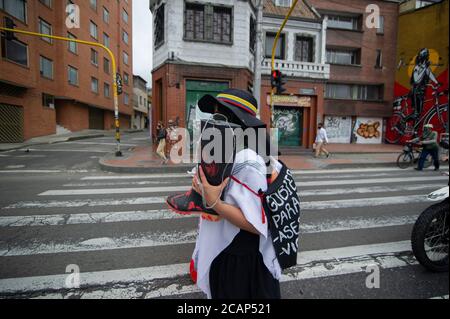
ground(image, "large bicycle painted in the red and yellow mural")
xmin=386 ymin=84 xmax=448 ymax=144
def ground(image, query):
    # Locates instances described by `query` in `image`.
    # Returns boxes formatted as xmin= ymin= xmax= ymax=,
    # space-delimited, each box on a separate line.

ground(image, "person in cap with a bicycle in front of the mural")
xmin=407 ymin=124 xmax=439 ymax=171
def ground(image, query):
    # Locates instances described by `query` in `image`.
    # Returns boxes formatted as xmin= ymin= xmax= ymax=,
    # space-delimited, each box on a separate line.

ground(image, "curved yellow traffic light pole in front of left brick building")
xmin=0 ymin=27 xmax=122 ymax=156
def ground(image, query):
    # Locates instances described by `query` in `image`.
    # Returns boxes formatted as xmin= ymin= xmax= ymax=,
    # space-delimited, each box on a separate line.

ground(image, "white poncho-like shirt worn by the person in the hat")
xmin=192 ymin=149 xmax=281 ymax=298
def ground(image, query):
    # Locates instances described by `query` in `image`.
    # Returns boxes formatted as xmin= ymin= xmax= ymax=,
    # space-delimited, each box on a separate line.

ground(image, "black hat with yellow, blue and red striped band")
xmin=198 ymin=89 xmax=266 ymax=128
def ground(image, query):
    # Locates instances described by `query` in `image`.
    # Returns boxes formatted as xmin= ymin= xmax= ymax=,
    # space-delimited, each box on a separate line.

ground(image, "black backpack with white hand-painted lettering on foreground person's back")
xmin=231 ymin=161 xmax=300 ymax=270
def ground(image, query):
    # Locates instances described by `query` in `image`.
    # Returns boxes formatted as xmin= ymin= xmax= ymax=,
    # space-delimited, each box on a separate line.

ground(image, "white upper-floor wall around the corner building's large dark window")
xmin=153 ymin=0 xmax=253 ymax=70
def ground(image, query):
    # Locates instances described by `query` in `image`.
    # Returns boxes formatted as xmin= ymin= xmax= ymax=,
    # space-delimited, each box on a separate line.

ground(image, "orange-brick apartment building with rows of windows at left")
xmin=0 ymin=0 xmax=133 ymax=143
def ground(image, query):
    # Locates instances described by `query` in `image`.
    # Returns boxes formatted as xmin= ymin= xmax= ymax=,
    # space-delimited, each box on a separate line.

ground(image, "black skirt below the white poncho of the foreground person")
xmin=209 ymin=230 xmax=281 ymax=299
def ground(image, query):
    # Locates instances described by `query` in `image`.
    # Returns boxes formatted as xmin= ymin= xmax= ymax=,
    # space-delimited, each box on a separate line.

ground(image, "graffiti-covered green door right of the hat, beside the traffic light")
xmin=274 ymin=106 xmax=303 ymax=146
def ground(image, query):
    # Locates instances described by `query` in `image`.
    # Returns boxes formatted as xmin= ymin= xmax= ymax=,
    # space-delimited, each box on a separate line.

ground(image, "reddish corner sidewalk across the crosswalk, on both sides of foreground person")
xmin=99 ymin=144 xmax=403 ymax=174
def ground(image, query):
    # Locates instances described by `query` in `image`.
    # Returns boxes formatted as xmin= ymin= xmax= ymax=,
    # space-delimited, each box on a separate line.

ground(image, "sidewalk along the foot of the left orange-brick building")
xmin=0 ymin=130 xmax=142 ymax=152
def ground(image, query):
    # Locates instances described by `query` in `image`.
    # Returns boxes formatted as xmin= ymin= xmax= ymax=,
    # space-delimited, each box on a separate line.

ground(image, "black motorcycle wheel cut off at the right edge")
xmin=411 ymin=198 xmax=449 ymax=272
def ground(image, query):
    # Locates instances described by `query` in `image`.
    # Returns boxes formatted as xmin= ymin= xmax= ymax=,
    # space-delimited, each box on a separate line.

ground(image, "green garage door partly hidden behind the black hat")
xmin=186 ymin=81 xmax=229 ymax=134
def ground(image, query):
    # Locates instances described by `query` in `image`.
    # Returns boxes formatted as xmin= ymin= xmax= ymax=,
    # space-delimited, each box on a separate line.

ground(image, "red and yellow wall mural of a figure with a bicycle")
xmin=385 ymin=0 xmax=449 ymax=144
